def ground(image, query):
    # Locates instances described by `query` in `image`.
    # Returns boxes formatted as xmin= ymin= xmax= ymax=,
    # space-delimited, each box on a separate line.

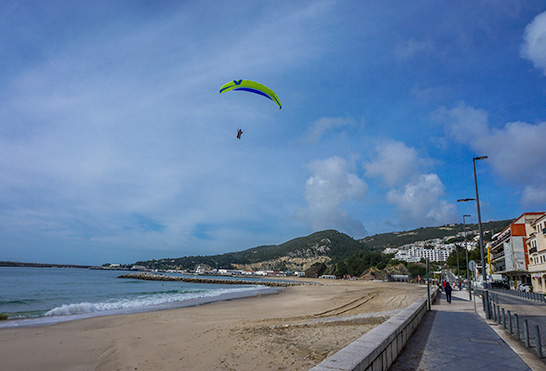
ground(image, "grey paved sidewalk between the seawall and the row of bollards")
xmin=391 ymin=291 xmax=531 ymax=371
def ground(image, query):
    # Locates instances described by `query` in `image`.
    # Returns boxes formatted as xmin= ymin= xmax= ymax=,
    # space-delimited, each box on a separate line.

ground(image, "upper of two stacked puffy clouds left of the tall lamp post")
xmin=363 ymin=140 xmax=423 ymax=186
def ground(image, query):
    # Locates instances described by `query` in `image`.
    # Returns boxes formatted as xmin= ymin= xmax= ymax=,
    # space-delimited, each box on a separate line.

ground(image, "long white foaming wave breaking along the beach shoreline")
xmin=45 ymin=286 xmax=264 ymax=316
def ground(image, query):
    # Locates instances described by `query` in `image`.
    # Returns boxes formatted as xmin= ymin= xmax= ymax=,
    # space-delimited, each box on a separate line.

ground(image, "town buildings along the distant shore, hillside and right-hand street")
xmin=96 ymin=212 xmax=546 ymax=293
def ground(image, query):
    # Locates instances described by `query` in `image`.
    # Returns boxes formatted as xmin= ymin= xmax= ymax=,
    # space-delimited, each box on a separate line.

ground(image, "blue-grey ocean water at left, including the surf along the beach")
xmin=0 ymin=267 xmax=277 ymax=329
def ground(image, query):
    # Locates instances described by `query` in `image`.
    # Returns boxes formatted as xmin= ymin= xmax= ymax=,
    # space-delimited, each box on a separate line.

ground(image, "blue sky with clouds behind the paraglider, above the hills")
xmin=0 ymin=0 xmax=546 ymax=264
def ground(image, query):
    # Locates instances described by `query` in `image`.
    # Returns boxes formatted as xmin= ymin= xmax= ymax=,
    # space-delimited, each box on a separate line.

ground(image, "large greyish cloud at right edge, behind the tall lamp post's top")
xmin=435 ymin=104 xmax=546 ymax=206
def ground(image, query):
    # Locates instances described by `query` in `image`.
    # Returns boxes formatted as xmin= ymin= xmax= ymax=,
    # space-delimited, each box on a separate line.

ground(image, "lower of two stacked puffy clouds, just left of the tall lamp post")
xmin=387 ymin=174 xmax=457 ymax=225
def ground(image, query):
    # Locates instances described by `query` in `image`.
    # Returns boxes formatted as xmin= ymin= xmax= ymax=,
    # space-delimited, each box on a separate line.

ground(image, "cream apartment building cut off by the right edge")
xmin=526 ymin=213 xmax=546 ymax=293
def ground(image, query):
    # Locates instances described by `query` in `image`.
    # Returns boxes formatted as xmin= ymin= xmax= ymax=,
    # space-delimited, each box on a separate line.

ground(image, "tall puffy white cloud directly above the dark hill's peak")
xmin=305 ymin=157 xmax=367 ymax=237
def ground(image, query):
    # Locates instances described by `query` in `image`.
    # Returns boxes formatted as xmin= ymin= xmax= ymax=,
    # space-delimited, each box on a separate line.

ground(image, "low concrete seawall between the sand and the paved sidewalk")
xmin=311 ymin=290 xmax=437 ymax=371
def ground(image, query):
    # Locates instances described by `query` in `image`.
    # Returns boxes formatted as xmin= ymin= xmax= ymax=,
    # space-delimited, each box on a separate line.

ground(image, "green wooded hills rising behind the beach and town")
xmin=135 ymin=220 xmax=511 ymax=276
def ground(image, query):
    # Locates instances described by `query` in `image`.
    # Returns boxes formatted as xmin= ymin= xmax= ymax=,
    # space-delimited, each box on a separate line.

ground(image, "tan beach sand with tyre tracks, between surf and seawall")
xmin=0 ymin=280 xmax=426 ymax=370
